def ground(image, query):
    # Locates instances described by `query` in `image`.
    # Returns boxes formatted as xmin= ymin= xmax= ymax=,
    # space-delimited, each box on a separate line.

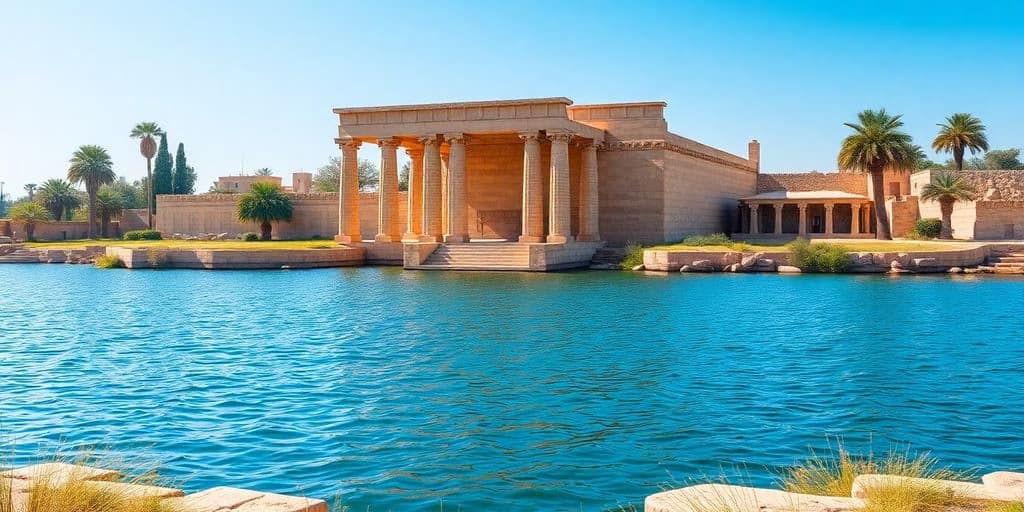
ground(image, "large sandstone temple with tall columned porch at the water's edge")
xmin=334 ymin=97 xmax=760 ymax=269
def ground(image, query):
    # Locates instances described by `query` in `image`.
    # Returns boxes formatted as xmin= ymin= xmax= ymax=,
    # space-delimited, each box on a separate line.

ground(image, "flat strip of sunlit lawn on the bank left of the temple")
xmin=26 ymin=240 xmax=342 ymax=251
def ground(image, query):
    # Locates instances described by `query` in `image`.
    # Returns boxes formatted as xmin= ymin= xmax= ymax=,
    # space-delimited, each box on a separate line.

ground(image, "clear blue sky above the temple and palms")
xmin=0 ymin=0 xmax=1024 ymax=193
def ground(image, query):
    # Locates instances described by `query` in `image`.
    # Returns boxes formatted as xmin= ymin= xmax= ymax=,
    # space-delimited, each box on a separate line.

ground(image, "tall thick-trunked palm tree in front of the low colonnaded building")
xmin=838 ymin=109 xmax=919 ymax=240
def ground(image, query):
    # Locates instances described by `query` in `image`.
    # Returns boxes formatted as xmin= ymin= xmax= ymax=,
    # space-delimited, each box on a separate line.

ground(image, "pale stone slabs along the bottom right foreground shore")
xmin=644 ymin=471 xmax=1024 ymax=512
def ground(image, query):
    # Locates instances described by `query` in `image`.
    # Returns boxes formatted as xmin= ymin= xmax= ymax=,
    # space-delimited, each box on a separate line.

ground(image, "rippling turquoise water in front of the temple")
xmin=0 ymin=265 xmax=1024 ymax=511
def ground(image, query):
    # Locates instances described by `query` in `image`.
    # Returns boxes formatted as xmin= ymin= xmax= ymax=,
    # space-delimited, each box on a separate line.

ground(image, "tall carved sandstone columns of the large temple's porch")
xmin=335 ymin=130 xmax=600 ymax=244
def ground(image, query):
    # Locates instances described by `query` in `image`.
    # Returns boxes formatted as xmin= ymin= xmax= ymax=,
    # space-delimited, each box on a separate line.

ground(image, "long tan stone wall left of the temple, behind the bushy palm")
xmin=155 ymin=193 xmax=408 ymax=240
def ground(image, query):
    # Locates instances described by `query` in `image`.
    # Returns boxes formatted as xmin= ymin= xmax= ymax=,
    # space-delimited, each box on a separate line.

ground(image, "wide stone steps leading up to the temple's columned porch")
xmin=410 ymin=242 xmax=530 ymax=270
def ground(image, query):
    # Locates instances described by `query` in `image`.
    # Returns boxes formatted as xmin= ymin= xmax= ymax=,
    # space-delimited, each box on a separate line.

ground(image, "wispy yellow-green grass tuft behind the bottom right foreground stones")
xmin=780 ymin=442 xmax=973 ymax=497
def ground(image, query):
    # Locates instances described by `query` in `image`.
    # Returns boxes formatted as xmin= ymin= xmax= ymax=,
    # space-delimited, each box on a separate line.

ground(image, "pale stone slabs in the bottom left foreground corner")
xmin=0 ymin=463 xmax=328 ymax=512
